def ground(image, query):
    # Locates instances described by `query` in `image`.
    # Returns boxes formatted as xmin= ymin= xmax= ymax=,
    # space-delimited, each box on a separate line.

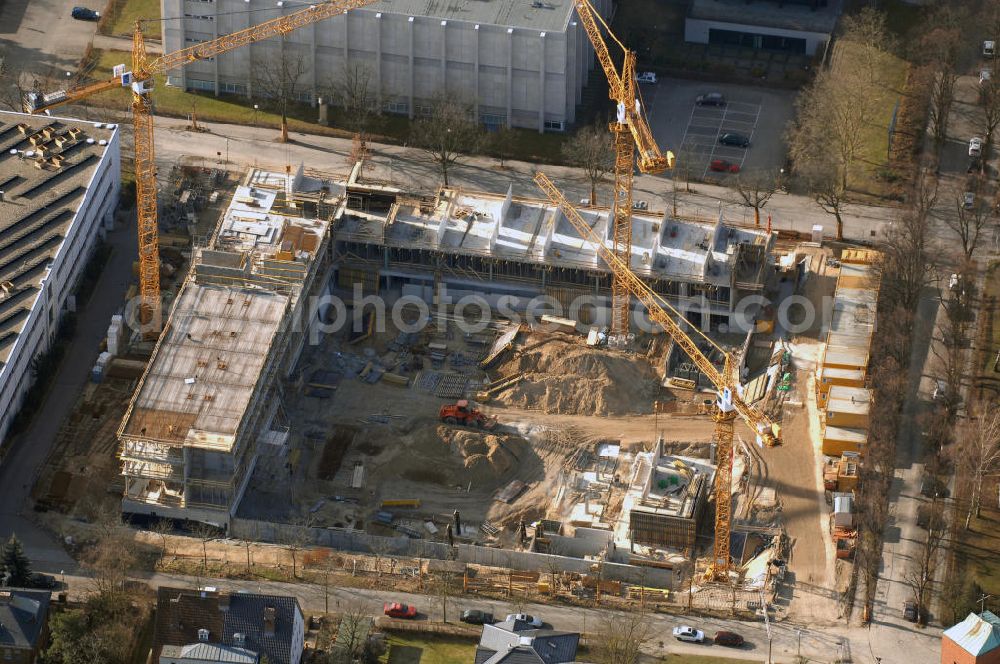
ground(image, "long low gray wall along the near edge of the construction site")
xmin=229 ymin=517 xmax=675 ymax=589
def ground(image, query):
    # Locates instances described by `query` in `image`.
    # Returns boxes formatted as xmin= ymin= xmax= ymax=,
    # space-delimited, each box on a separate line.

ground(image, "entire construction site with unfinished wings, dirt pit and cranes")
xmin=23 ymin=3 xmax=878 ymax=617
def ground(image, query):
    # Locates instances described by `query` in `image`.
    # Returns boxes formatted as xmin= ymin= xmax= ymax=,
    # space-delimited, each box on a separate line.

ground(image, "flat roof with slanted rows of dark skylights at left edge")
xmin=0 ymin=111 xmax=118 ymax=367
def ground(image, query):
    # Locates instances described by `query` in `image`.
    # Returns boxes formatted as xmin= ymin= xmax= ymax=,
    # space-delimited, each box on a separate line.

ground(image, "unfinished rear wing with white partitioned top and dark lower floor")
xmin=334 ymin=169 xmax=774 ymax=332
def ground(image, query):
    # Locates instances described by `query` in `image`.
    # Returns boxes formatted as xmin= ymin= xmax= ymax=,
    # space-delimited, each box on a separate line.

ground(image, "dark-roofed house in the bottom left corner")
xmin=0 ymin=588 xmax=51 ymax=664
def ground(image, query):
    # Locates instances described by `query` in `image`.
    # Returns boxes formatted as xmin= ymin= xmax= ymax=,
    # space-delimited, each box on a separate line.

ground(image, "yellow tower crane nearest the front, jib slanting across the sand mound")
xmin=535 ymin=172 xmax=781 ymax=581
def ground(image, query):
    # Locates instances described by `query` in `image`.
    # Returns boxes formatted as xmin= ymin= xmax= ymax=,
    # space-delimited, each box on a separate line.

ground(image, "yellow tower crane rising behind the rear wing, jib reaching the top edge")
xmin=576 ymin=0 xmax=674 ymax=335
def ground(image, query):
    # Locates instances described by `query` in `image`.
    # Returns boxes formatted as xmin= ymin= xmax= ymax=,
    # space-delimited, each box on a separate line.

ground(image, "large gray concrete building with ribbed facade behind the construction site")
xmin=161 ymin=0 xmax=611 ymax=132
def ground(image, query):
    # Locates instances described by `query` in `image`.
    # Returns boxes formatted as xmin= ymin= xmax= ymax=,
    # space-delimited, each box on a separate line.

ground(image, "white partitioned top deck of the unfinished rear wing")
xmin=334 ymin=183 xmax=771 ymax=286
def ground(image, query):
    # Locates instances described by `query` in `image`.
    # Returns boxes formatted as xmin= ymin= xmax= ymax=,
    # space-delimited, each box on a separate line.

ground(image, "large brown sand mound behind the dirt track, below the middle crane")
xmin=497 ymin=338 xmax=658 ymax=415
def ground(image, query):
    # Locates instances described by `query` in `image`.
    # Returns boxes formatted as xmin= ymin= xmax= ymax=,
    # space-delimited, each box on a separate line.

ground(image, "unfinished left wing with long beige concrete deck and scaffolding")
xmin=118 ymin=169 xmax=339 ymax=526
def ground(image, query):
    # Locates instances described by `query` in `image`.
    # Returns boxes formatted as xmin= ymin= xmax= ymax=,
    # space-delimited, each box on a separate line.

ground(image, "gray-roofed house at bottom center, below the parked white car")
xmin=475 ymin=620 xmax=580 ymax=664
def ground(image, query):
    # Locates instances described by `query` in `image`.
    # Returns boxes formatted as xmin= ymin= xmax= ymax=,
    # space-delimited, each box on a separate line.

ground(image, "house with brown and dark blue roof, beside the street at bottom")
xmin=153 ymin=588 xmax=305 ymax=664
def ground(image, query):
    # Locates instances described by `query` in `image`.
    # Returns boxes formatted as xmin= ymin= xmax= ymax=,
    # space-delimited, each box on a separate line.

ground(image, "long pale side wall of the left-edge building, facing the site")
xmin=0 ymin=124 xmax=121 ymax=440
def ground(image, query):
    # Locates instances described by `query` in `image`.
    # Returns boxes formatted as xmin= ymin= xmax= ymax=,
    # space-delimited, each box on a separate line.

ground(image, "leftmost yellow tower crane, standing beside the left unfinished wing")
xmin=24 ymin=0 xmax=375 ymax=336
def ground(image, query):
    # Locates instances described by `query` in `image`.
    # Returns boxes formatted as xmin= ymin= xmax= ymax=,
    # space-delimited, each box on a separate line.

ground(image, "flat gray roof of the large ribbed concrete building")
xmin=363 ymin=0 xmax=575 ymax=31
